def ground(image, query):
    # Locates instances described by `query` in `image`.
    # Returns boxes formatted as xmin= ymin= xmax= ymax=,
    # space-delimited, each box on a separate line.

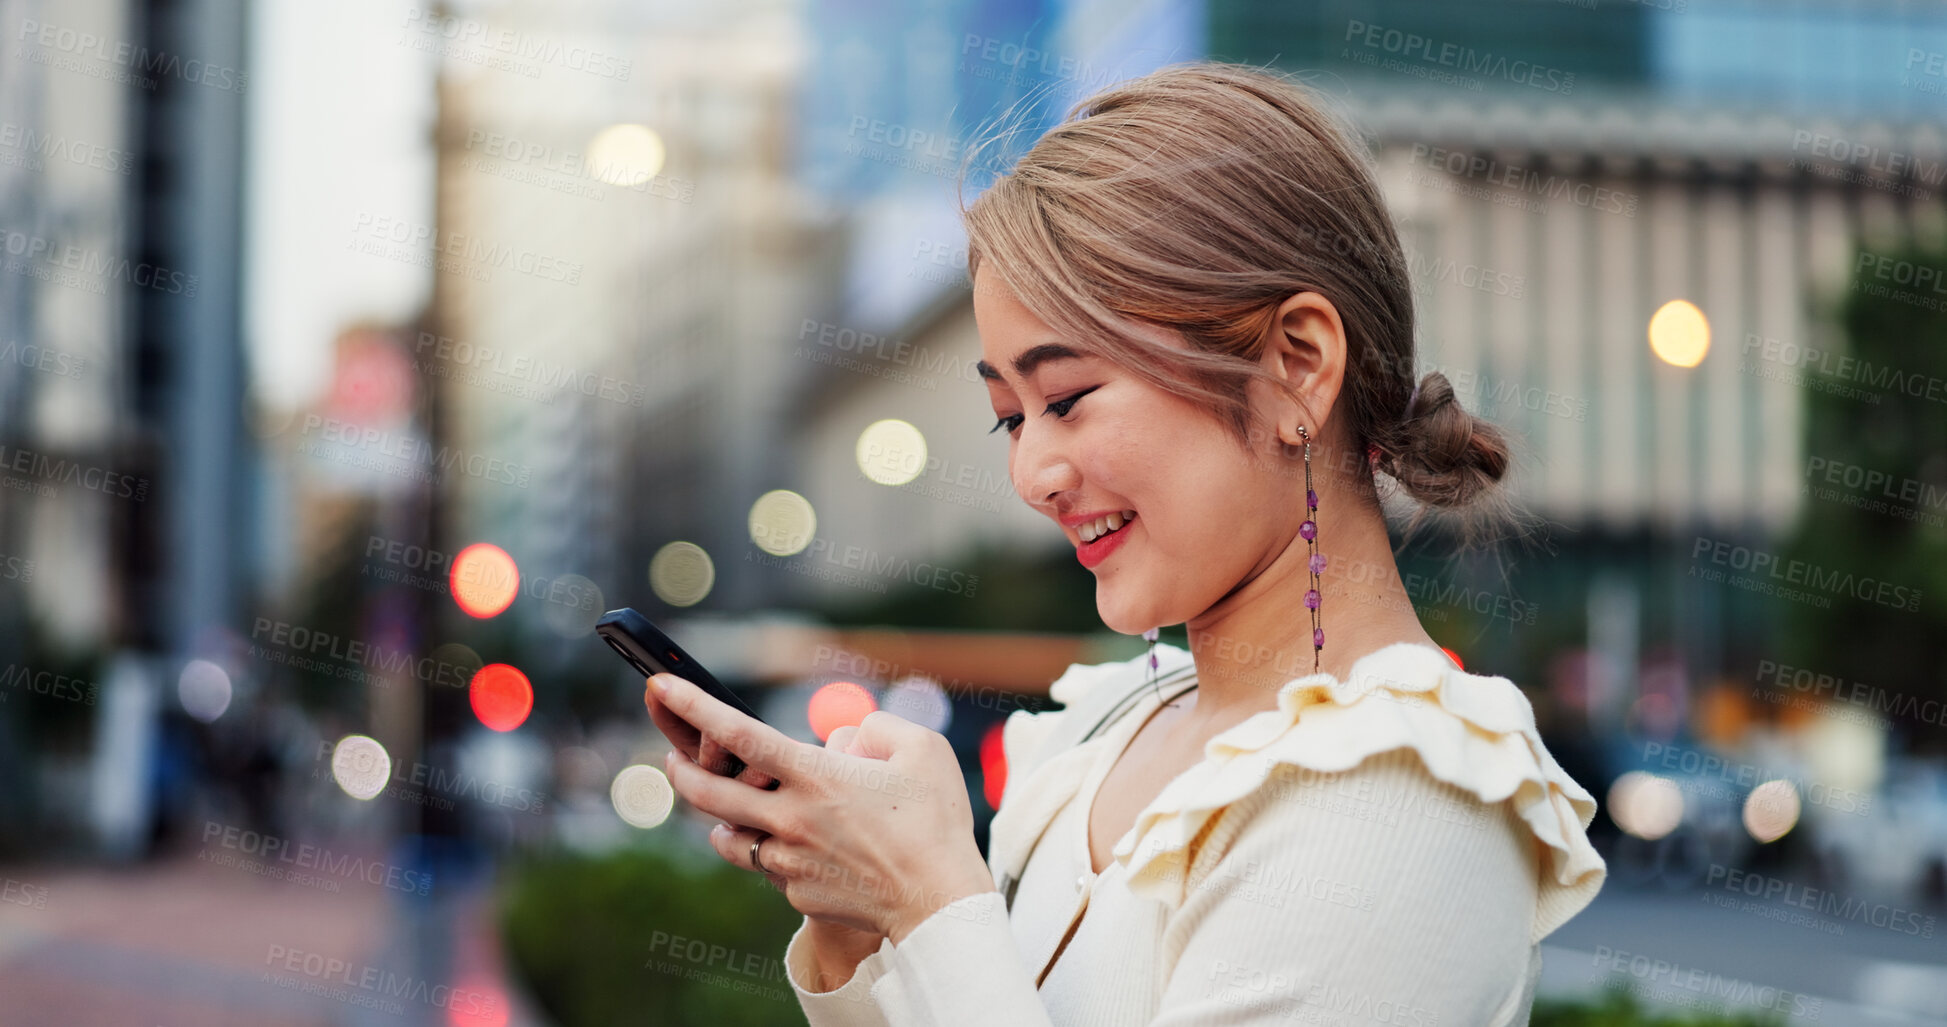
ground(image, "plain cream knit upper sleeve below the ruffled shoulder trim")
xmin=1162 ymin=748 xmax=1540 ymax=1025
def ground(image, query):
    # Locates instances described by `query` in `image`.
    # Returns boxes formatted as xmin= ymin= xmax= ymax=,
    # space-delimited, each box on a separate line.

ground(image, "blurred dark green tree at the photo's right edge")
xmin=1774 ymin=236 xmax=1947 ymax=744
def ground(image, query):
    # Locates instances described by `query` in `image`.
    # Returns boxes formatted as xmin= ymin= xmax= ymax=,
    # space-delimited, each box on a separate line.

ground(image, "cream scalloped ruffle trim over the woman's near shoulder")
xmin=1116 ymin=645 xmax=1606 ymax=941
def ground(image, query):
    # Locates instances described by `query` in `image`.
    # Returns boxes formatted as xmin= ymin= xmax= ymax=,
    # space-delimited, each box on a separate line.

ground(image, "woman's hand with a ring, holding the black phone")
xmin=650 ymin=674 xmax=995 ymax=943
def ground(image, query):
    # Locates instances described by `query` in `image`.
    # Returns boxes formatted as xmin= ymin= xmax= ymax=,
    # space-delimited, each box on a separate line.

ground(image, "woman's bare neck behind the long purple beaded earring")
xmin=1186 ymin=489 xmax=1433 ymax=719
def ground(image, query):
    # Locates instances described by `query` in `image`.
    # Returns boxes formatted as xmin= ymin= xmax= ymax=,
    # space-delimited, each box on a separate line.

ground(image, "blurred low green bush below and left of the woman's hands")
xmin=500 ymin=850 xmax=804 ymax=1027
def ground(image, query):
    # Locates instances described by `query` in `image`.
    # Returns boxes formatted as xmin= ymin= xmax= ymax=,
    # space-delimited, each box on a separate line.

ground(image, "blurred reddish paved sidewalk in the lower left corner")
xmin=0 ymin=857 xmax=547 ymax=1027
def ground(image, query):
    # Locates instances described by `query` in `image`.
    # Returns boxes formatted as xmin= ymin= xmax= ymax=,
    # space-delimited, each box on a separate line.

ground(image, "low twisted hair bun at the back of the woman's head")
xmin=1386 ymin=370 xmax=1509 ymax=507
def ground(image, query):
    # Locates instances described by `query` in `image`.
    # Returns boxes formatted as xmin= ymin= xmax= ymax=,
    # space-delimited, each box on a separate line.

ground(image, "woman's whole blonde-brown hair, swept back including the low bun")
xmin=962 ymin=60 xmax=1509 ymax=507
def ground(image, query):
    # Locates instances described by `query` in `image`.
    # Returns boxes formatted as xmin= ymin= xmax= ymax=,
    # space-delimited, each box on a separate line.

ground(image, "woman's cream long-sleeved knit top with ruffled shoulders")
xmin=785 ymin=643 xmax=1606 ymax=1027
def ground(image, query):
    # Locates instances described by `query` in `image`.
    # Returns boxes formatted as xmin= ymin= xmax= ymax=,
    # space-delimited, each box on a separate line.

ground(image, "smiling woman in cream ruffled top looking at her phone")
xmin=646 ymin=62 xmax=1604 ymax=1027
